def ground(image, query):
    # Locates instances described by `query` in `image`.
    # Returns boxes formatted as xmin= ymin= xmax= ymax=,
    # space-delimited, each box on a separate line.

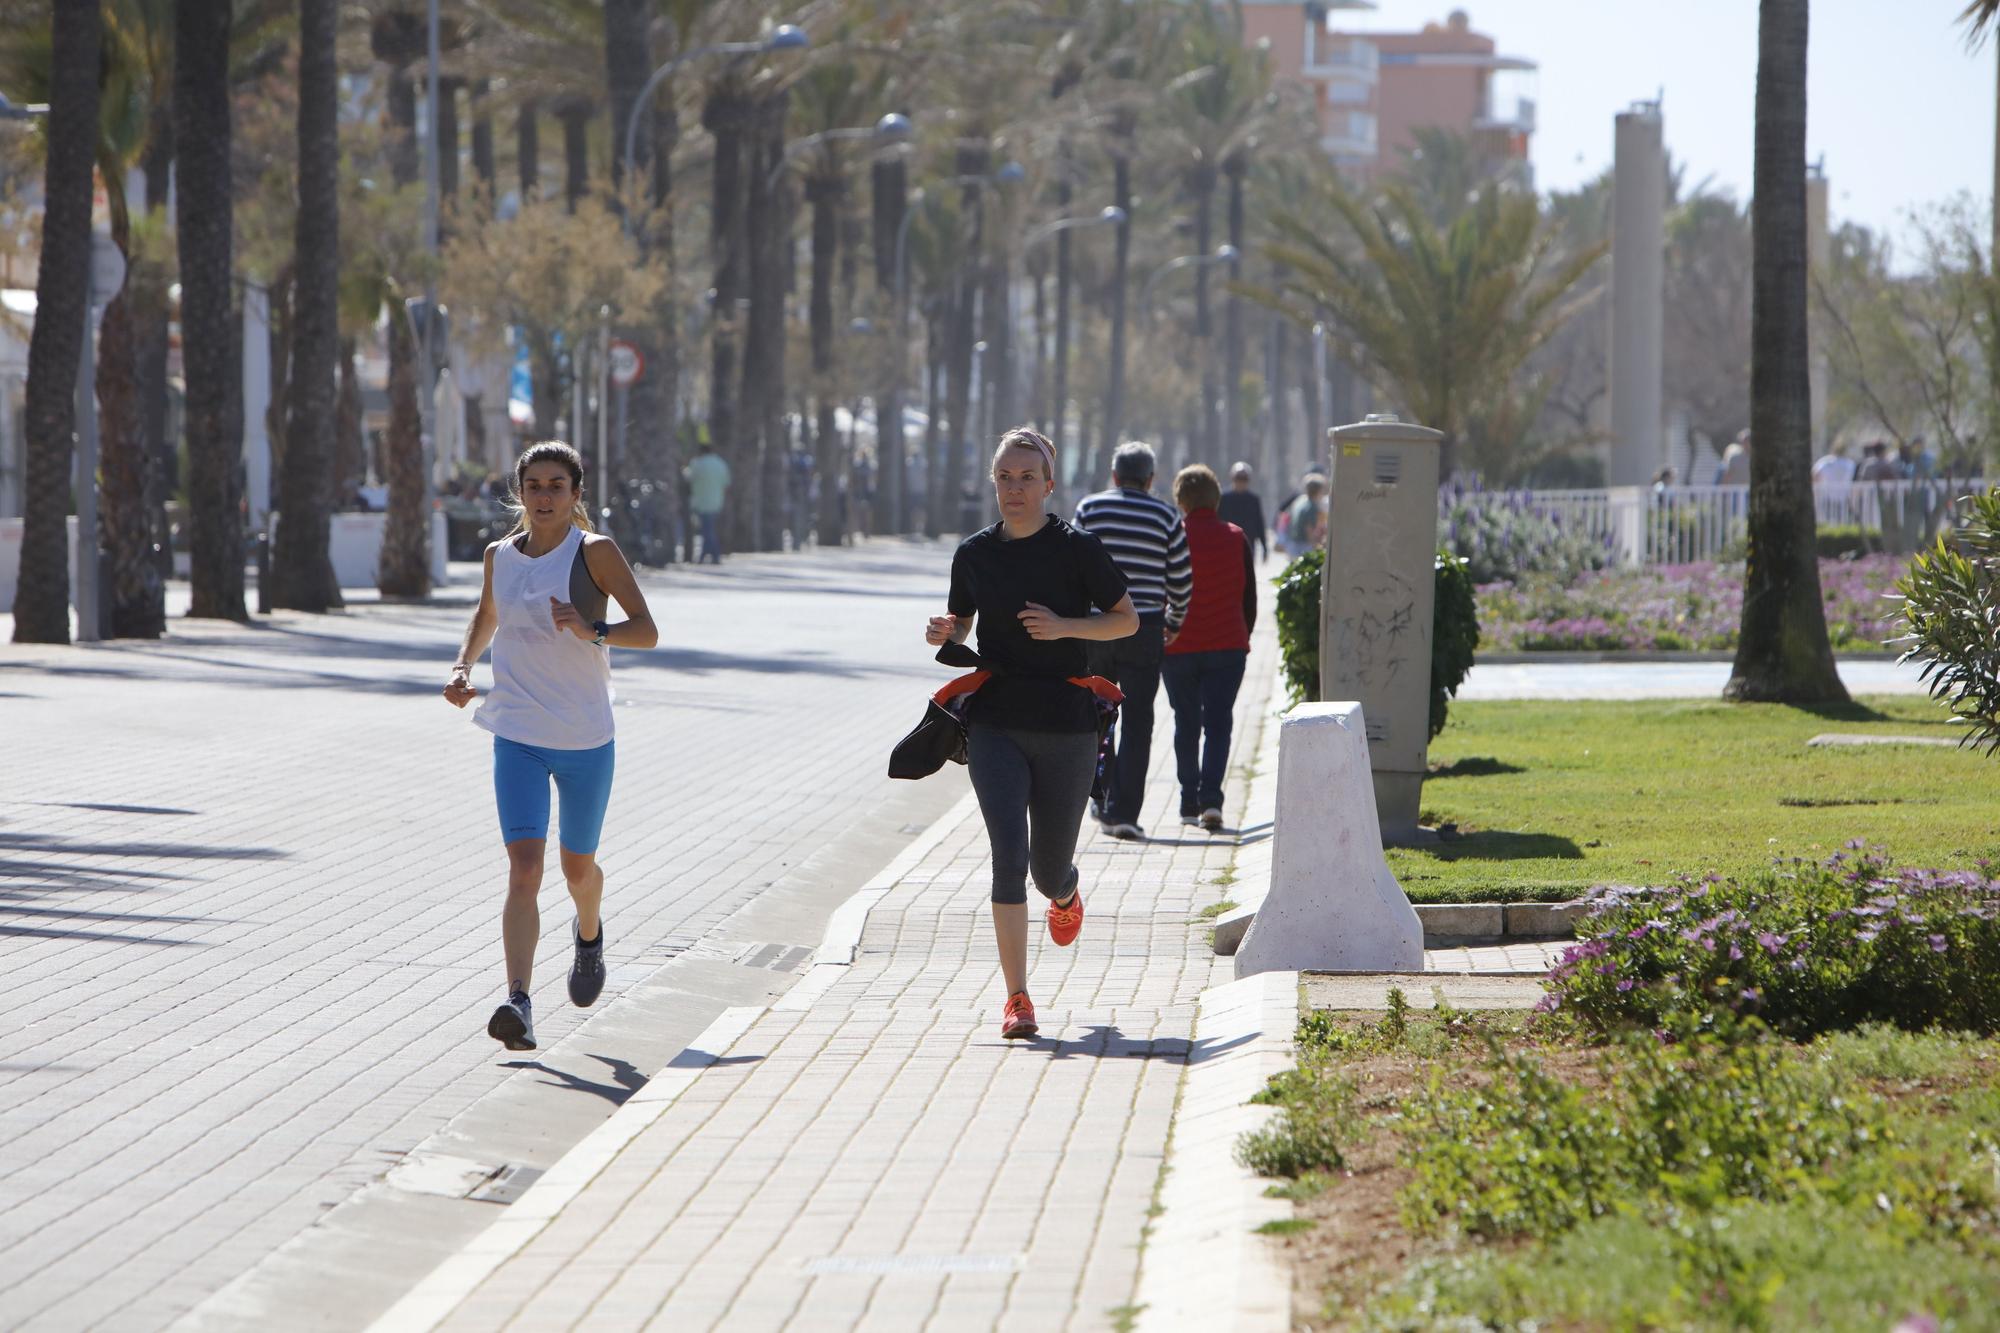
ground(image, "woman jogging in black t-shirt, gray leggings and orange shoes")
xmin=924 ymin=428 xmax=1140 ymax=1037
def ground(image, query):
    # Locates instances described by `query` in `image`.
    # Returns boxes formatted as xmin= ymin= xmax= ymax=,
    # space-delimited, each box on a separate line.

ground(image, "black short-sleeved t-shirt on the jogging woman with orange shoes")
xmin=948 ymin=514 xmax=1126 ymax=731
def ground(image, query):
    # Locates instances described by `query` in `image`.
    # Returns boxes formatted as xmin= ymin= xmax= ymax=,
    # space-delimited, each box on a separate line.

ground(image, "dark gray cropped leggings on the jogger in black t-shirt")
xmin=966 ymin=723 xmax=1098 ymax=903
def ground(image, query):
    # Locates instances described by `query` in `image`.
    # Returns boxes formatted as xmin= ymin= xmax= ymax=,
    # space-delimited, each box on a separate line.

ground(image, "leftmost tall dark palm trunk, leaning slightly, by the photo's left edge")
xmin=14 ymin=4 xmax=104 ymax=642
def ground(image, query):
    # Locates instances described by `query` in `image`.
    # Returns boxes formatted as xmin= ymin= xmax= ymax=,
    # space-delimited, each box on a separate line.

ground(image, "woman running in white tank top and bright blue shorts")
xmin=444 ymin=440 xmax=660 ymax=1051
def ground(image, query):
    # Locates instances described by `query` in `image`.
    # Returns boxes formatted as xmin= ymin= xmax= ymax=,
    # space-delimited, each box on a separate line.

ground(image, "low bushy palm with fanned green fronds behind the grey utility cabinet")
xmin=1242 ymin=164 xmax=1602 ymax=474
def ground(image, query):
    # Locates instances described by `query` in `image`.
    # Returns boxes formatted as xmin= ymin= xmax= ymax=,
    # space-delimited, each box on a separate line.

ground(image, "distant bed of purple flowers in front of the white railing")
xmin=1478 ymin=556 xmax=1908 ymax=652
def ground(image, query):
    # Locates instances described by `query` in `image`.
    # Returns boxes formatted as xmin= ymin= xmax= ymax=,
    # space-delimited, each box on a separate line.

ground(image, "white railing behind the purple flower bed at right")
xmin=1438 ymin=478 xmax=1990 ymax=566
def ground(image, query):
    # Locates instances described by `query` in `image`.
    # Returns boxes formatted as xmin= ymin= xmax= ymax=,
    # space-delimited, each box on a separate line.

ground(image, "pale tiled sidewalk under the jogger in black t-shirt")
xmin=390 ymin=630 xmax=1276 ymax=1331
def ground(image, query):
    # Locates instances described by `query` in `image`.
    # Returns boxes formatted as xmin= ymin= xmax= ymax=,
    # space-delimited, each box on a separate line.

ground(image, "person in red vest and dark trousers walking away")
xmin=1164 ymin=462 xmax=1256 ymax=833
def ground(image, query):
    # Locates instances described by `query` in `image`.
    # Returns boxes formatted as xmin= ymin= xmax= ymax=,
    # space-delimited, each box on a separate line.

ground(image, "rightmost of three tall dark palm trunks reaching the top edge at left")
xmin=270 ymin=0 xmax=342 ymax=610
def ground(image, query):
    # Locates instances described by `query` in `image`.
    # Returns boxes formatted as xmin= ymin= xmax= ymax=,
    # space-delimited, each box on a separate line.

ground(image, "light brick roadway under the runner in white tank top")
xmin=0 ymin=542 xmax=976 ymax=1329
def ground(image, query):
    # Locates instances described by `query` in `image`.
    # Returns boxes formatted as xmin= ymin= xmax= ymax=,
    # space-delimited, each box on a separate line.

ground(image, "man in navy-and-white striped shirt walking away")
xmin=1076 ymin=444 xmax=1194 ymax=841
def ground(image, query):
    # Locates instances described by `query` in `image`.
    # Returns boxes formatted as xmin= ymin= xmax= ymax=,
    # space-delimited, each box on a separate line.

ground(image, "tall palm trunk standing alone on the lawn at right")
xmin=1722 ymin=0 xmax=1848 ymax=703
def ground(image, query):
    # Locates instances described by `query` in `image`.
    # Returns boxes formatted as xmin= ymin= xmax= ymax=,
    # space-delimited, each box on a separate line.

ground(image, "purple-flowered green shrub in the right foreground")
xmin=1542 ymin=843 xmax=2000 ymax=1037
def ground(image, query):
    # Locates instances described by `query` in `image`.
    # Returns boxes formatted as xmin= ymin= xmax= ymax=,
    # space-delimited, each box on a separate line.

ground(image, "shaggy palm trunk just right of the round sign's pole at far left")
xmin=96 ymin=180 xmax=166 ymax=638
